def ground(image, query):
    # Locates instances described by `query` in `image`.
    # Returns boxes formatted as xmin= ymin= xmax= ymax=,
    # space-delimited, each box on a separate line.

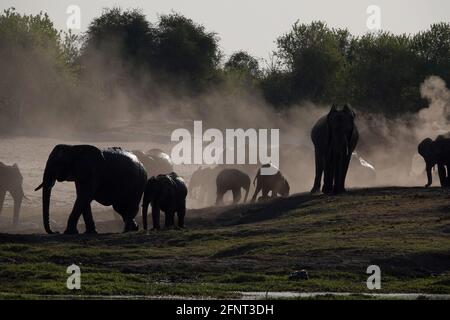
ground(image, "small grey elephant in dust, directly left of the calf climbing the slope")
xmin=216 ymin=169 xmax=250 ymax=205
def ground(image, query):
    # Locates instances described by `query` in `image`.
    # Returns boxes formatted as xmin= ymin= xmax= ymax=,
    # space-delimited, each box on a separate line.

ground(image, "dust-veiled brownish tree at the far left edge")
xmin=0 ymin=8 xmax=75 ymax=129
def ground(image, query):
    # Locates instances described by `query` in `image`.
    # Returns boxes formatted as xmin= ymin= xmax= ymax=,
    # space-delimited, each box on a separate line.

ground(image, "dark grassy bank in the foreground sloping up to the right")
xmin=0 ymin=188 xmax=450 ymax=299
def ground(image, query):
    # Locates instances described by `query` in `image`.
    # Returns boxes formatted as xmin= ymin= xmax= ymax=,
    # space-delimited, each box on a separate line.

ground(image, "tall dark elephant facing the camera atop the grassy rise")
xmin=311 ymin=104 xmax=359 ymax=194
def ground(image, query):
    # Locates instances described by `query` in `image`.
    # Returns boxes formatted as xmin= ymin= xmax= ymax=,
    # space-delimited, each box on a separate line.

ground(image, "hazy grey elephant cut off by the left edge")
xmin=0 ymin=162 xmax=25 ymax=226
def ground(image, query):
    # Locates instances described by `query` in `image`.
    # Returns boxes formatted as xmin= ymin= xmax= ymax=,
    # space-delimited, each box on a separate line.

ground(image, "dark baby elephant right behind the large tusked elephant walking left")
xmin=142 ymin=172 xmax=187 ymax=230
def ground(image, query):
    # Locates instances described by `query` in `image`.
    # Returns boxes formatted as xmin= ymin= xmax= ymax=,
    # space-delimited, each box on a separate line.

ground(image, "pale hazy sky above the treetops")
xmin=0 ymin=0 xmax=450 ymax=58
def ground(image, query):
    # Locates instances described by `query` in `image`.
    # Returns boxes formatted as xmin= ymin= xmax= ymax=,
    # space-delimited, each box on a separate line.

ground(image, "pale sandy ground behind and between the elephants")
xmin=0 ymin=127 xmax=436 ymax=232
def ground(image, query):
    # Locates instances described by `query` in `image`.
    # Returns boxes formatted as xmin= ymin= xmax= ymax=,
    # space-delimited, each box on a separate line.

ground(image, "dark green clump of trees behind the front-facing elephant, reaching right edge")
xmin=268 ymin=22 xmax=450 ymax=116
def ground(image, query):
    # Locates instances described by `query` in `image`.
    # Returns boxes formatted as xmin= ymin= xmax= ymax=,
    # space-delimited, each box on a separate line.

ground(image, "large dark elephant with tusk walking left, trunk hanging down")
xmin=35 ymin=144 xmax=147 ymax=234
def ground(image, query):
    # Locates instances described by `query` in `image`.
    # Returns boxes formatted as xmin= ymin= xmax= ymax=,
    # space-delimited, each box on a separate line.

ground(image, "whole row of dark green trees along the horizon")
xmin=0 ymin=8 xmax=450 ymax=132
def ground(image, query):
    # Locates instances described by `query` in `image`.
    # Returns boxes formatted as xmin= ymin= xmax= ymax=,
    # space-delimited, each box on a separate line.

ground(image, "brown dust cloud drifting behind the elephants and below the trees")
xmin=0 ymin=40 xmax=450 ymax=222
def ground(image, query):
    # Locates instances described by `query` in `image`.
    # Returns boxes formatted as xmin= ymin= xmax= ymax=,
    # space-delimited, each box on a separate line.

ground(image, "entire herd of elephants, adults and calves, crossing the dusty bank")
xmin=0 ymin=105 xmax=450 ymax=234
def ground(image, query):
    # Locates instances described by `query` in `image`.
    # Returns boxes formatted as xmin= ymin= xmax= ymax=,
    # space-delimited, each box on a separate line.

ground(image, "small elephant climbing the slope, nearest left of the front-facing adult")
xmin=251 ymin=164 xmax=291 ymax=202
